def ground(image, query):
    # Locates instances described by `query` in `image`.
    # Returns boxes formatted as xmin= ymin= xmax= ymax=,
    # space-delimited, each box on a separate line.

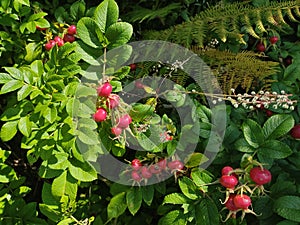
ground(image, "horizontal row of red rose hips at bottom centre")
xmin=130 ymin=158 xmax=184 ymax=184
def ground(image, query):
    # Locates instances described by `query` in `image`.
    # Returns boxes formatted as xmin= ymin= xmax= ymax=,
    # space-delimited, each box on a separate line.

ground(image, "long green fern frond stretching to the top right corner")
xmin=144 ymin=0 xmax=300 ymax=47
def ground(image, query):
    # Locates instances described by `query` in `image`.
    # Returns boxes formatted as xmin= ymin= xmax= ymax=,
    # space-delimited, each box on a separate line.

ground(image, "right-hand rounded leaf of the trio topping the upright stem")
xmin=105 ymin=22 xmax=133 ymax=49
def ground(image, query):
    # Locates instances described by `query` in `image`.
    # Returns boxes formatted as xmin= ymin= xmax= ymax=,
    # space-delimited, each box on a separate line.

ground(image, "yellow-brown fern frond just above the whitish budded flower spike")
xmin=192 ymin=47 xmax=278 ymax=94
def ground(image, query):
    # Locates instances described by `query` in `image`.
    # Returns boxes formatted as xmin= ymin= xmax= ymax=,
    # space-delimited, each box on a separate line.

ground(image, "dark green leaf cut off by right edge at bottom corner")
xmin=274 ymin=196 xmax=300 ymax=223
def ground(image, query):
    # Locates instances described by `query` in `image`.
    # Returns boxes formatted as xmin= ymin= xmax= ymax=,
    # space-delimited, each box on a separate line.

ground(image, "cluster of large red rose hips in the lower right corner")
xmin=219 ymin=166 xmax=272 ymax=221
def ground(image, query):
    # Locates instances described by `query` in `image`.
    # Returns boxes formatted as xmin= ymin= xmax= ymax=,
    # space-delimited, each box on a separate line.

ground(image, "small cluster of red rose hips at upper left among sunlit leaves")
xmin=45 ymin=25 xmax=77 ymax=51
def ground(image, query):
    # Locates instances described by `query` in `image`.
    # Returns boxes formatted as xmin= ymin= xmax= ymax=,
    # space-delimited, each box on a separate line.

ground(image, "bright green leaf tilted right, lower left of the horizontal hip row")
xmin=107 ymin=192 xmax=127 ymax=220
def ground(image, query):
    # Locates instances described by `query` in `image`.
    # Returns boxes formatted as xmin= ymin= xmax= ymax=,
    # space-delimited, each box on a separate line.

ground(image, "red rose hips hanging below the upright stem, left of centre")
xmin=93 ymin=82 xmax=132 ymax=136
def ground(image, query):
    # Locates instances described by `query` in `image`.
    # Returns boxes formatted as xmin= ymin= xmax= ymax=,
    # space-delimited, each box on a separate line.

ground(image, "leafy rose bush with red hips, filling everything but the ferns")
xmin=0 ymin=0 xmax=300 ymax=225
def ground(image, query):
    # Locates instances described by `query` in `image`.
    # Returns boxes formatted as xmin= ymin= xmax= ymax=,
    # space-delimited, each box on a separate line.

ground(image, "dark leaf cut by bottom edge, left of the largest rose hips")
xmin=195 ymin=198 xmax=220 ymax=225
